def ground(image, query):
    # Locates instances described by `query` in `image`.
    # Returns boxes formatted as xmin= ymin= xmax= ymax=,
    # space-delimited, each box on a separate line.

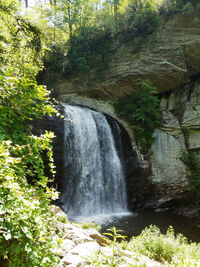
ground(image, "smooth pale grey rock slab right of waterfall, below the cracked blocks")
xmin=152 ymin=130 xmax=188 ymax=193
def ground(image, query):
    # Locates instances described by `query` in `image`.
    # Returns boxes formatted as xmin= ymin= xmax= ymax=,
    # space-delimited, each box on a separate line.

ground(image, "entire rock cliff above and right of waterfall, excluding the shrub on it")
xmin=50 ymin=3 xmax=200 ymax=203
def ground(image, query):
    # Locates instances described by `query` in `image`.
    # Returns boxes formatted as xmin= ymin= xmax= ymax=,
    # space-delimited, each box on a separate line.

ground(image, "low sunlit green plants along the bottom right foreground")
xmin=87 ymin=225 xmax=200 ymax=267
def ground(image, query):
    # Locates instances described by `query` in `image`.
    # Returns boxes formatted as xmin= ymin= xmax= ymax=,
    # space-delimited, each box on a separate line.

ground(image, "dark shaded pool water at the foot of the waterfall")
xmin=102 ymin=210 xmax=200 ymax=242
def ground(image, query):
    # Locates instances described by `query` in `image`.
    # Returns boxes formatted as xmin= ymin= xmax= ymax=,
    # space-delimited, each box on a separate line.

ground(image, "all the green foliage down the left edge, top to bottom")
xmin=0 ymin=0 xmax=59 ymax=267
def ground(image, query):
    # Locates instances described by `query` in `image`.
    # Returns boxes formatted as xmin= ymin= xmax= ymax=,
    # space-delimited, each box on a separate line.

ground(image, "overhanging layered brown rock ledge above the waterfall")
xmin=56 ymin=4 xmax=200 ymax=99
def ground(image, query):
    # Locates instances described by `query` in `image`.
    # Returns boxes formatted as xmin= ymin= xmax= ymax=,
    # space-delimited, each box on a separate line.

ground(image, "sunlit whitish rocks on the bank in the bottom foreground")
xmin=53 ymin=206 xmax=163 ymax=267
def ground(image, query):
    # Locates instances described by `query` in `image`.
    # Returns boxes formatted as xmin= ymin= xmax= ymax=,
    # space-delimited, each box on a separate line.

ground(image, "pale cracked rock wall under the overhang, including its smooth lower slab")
xmin=151 ymin=82 xmax=200 ymax=193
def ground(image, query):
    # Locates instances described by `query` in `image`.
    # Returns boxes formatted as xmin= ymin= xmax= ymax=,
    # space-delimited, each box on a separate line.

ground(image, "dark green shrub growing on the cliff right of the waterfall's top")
xmin=115 ymin=80 xmax=160 ymax=152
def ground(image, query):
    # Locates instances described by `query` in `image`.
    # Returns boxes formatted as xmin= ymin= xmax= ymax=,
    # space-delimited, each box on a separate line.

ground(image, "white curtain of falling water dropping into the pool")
xmin=61 ymin=105 xmax=127 ymax=220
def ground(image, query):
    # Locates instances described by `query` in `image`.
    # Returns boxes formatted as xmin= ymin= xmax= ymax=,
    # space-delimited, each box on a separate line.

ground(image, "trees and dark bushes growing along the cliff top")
xmin=22 ymin=0 xmax=197 ymax=79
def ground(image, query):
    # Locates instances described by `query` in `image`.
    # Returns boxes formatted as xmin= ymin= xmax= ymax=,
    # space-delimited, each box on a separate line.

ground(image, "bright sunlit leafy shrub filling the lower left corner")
xmin=0 ymin=137 xmax=59 ymax=267
